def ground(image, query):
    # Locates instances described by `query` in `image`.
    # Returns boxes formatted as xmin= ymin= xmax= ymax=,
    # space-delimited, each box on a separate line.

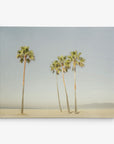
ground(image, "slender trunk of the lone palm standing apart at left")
xmin=21 ymin=58 xmax=26 ymax=114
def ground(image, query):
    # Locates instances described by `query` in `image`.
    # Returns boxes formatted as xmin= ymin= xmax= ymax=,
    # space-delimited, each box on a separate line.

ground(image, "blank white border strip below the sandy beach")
xmin=0 ymin=119 xmax=114 ymax=144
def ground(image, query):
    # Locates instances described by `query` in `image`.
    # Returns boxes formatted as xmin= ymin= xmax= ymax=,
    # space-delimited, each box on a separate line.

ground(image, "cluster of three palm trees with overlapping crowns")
xmin=50 ymin=51 xmax=85 ymax=113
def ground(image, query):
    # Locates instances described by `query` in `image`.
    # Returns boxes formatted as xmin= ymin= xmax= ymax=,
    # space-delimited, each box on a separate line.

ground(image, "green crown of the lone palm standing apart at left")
xmin=17 ymin=46 xmax=35 ymax=63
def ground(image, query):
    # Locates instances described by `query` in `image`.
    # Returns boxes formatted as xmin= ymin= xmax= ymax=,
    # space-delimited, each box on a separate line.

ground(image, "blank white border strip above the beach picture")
xmin=0 ymin=0 xmax=114 ymax=26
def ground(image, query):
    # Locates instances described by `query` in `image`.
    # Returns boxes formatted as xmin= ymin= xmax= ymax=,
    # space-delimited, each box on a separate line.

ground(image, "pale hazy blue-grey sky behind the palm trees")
xmin=0 ymin=27 xmax=114 ymax=108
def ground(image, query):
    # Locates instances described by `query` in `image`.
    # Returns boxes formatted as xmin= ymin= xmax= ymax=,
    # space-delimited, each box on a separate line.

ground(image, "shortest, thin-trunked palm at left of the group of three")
xmin=50 ymin=60 xmax=62 ymax=112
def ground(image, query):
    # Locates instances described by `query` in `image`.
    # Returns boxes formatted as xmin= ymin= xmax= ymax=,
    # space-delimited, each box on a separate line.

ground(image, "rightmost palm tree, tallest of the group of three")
xmin=68 ymin=51 xmax=85 ymax=113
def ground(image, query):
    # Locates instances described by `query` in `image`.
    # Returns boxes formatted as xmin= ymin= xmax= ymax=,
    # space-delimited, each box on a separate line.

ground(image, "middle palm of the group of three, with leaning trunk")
xmin=58 ymin=56 xmax=70 ymax=113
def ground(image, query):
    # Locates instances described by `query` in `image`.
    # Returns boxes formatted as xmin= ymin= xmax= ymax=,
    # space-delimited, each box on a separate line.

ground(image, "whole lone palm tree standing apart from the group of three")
xmin=17 ymin=46 xmax=35 ymax=114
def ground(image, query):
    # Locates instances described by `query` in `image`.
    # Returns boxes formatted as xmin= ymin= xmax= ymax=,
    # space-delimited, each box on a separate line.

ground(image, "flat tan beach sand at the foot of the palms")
xmin=0 ymin=109 xmax=114 ymax=118
